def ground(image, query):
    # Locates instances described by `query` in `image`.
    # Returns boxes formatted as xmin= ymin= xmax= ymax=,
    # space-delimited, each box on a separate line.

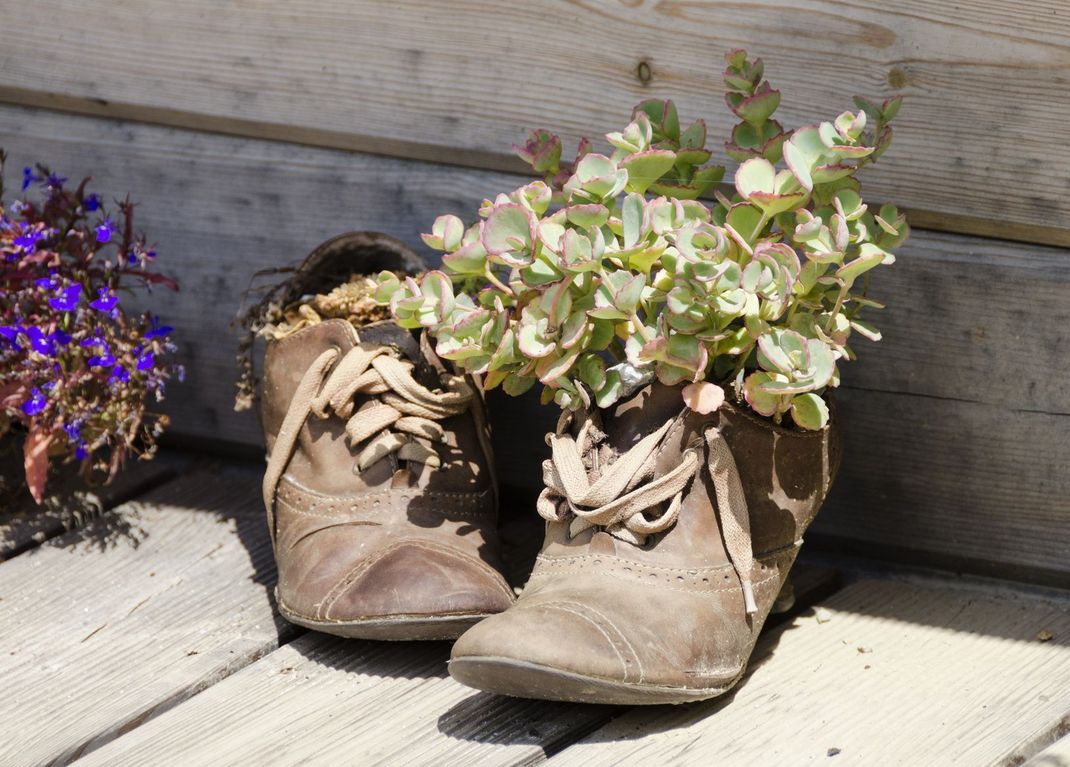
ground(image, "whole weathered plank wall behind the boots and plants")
xmin=0 ymin=0 xmax=1070 ymax=585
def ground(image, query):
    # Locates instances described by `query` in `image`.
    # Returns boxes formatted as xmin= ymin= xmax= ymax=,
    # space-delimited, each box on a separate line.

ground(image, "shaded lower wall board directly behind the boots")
xmin=0 ymin=107 xmax=1070 ymax=581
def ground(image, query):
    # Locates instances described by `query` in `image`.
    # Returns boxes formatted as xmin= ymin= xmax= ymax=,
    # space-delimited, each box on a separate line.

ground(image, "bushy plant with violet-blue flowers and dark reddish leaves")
xmin=0 ymin=152 xmax=182 ymax=503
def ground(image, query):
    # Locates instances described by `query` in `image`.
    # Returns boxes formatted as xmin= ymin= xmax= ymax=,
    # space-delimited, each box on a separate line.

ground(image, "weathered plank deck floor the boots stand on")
xmin=0 ymin=456 xmax=1070 ymax=767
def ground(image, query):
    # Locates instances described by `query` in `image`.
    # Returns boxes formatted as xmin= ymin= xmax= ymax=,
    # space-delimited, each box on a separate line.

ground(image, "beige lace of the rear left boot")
xmin=263 ymin=344 xmax=475 ymax=534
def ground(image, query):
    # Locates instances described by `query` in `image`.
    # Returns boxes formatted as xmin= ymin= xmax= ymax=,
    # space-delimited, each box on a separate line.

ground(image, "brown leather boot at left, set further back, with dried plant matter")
xmin=261 ymin=232 xmax=514 ymax=640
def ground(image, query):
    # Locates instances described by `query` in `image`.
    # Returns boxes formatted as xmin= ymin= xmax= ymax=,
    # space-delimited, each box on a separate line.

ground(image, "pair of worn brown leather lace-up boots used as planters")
xmin=254 ymin=233 xmax=839 ymax=704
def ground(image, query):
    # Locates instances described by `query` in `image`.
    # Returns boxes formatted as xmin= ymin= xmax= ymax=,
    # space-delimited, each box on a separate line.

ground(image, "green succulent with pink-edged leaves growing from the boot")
xmin=377 ymin=50 xmax=908 ymax=429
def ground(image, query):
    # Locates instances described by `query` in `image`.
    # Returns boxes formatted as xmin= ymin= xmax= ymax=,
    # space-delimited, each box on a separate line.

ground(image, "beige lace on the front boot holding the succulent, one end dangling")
xmin=537 ymin=410 xmax=758 ymax=613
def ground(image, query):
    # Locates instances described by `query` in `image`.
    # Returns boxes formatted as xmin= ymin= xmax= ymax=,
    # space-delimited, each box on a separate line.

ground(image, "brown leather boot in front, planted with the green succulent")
xmin=449 ymin=384 xmax=840 ymax=704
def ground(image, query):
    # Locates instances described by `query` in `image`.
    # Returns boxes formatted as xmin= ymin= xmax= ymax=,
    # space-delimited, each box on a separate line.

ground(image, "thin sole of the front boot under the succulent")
xmin=449 ymin=656 xmax=743 ymax=706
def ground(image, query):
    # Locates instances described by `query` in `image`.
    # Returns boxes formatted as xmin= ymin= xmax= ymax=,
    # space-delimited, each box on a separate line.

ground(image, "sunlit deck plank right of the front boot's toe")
xmin=550 ymin=580 xmax=1070 ymax=767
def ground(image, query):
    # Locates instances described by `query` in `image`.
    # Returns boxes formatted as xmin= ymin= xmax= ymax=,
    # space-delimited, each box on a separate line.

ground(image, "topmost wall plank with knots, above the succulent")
xmin=0 ymin=0 xmax=1070 ymax=244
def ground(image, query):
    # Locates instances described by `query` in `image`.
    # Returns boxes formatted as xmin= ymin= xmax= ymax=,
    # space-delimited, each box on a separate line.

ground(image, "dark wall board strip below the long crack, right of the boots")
xmin=811 ymin=390 xmax=1070 ymax=586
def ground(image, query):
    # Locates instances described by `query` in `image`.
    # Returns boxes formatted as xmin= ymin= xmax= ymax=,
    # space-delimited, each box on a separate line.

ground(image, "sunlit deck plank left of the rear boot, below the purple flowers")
xmin=0 ymin=459 xmax=295 ymax=765
